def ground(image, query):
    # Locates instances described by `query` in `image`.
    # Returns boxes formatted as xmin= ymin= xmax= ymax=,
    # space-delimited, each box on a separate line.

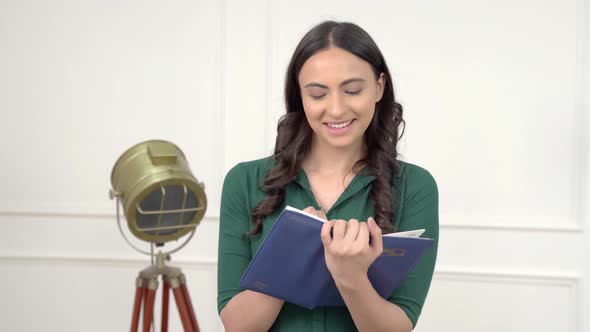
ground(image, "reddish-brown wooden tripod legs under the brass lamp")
xmin=131 ymin=252 xmax=199 ymax=332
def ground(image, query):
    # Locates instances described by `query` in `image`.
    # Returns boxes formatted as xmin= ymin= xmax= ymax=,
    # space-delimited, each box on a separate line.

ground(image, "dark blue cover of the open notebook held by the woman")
xmin=240 ymin=207 xmax=433 ymax=309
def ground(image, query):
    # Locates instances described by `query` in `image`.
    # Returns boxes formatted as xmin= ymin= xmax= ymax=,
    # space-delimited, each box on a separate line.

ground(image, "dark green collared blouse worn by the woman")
xmin=217 ymin=158 xmax=438 ymax=332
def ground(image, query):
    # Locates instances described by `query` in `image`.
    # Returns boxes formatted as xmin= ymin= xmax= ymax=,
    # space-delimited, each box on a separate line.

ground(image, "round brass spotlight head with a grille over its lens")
xmin=111 ymin=140 xmax=207 ymax=244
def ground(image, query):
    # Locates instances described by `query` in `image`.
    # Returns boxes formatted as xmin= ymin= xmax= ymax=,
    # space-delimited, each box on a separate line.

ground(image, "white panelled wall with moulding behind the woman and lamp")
xmin=0 ymin=0 xmax=590 ymax=332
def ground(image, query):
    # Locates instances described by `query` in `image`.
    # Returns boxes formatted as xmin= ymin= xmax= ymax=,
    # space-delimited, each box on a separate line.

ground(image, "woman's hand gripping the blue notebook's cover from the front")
xmin=321 ymin=217 xmax=383 ymax=287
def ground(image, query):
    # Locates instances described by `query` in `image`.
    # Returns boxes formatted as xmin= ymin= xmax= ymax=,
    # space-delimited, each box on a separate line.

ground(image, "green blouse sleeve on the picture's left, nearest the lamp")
xmin=217 ymin=164 xmax=252 ymax=312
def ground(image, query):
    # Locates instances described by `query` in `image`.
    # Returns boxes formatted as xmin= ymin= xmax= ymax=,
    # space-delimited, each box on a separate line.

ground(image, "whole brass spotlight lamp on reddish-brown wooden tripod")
xmin=110 ymin=140 xmax=207 ymax=332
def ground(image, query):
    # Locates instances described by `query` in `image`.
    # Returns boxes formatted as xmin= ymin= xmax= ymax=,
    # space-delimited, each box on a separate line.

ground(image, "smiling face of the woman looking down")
xmin=299 ymin=47 xmax=385 ymax=150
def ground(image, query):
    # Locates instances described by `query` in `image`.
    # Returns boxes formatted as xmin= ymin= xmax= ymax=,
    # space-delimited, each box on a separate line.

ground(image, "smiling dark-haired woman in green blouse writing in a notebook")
xmin=218 ymin=21 xmax=438 ymax=332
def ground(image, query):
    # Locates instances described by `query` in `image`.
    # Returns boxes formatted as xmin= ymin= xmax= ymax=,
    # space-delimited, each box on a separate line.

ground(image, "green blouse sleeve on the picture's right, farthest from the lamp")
xmin=388 ymin=165 xmax=438 ymax=327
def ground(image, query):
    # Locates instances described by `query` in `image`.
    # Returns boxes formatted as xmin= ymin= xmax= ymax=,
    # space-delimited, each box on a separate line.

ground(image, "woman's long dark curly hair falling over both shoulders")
xmin=247 ymin=21 xmax=405 ymax=235
